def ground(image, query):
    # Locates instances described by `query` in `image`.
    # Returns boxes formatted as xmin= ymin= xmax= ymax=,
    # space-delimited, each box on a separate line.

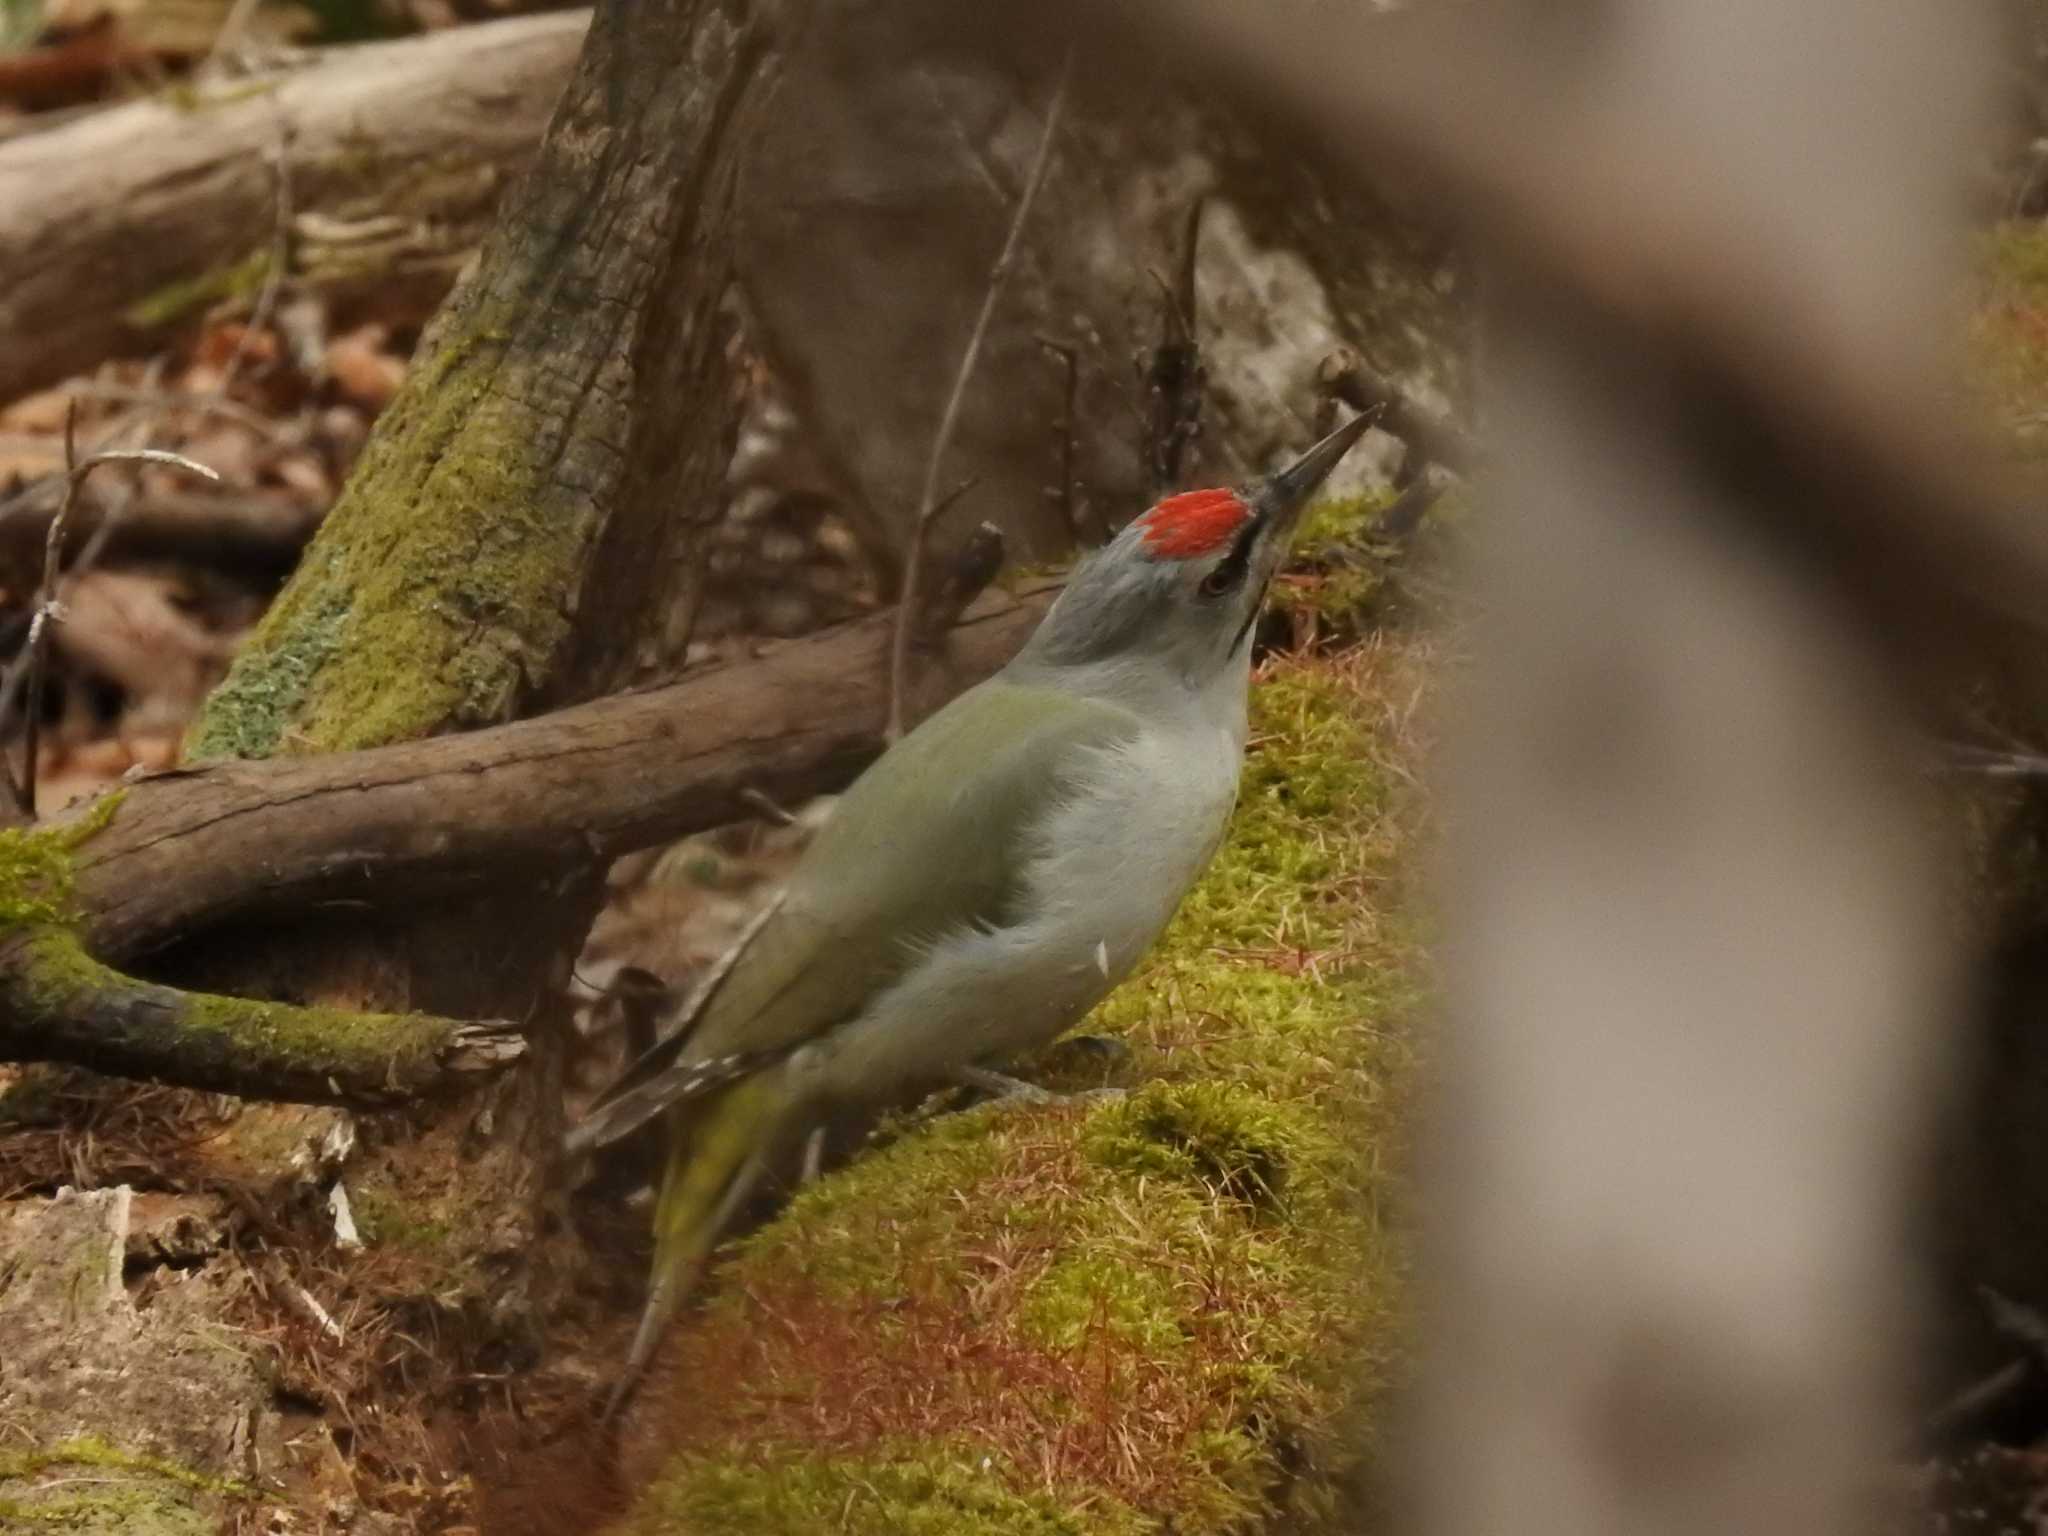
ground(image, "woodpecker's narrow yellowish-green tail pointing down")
xmin=604 ymin=1073 xmax=780 ymax=1421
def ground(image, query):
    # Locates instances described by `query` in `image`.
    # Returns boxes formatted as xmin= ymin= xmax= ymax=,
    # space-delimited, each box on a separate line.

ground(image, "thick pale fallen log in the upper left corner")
xmin=0 ymin=12 xmax=586 ymax=399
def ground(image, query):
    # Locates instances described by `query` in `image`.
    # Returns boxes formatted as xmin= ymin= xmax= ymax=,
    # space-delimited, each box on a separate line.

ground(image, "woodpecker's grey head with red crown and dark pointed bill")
xmin=1018 ymin=416 xmax=1368 ymax=688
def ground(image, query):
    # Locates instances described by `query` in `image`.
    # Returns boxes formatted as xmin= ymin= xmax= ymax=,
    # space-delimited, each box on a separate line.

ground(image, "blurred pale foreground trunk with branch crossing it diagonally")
xmin=974 ymin=0 xmax=1998 ymax=1536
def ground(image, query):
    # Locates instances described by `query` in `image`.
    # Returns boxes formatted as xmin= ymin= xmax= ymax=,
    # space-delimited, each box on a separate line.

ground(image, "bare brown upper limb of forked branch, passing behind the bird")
xmin=74 ymin=586 xmax=1051 ymax=963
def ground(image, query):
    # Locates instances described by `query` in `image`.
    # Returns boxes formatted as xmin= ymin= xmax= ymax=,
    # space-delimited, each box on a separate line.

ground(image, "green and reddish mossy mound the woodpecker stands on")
xmin=627 ymin=639 xmax=1423 ymax=1536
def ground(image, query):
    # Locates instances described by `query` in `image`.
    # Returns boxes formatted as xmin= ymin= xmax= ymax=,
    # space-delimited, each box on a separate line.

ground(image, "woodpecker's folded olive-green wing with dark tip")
xmin=578 ymin=676 xmax=1139 ymax=1145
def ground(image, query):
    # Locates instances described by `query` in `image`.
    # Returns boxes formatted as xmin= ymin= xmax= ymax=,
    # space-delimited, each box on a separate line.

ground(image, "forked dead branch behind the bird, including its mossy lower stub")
xmin=0 ymin=585 xmax=1053 ymax=1104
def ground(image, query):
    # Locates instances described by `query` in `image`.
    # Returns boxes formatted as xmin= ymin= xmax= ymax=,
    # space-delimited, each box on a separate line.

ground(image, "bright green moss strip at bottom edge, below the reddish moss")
xmin=625 ymin=1446 xmax=1157 ymax=1536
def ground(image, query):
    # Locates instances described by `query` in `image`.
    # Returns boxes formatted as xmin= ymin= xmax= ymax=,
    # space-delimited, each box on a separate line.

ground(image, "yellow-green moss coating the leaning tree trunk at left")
xmin=186 ymin=315 xmax=596 ymax=758
